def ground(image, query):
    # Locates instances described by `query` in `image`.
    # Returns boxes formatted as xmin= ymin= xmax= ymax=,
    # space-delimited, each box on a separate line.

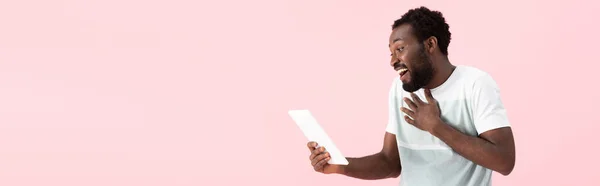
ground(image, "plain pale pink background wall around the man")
xmin=0 ymin=0 xmax=600 ymax=186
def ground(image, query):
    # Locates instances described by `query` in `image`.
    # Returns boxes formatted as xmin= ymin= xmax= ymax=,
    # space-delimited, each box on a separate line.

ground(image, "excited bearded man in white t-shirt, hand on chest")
xmin=307 ymin=7 xmax=515 ymax=186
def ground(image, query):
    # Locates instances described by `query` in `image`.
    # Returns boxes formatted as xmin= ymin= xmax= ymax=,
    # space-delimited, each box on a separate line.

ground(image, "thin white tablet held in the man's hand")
xmin=288 ymin=110 xmax=348 ymax=165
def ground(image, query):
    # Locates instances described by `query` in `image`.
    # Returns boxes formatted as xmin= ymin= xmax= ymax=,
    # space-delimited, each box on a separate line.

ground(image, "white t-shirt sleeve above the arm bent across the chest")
xmin=471 ymin=74 xmax=510 ymax=135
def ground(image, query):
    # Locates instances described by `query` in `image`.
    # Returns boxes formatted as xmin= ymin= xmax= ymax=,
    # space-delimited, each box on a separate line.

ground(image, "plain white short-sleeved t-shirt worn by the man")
xmin=386 ymin=66 xmax=510 ymax=186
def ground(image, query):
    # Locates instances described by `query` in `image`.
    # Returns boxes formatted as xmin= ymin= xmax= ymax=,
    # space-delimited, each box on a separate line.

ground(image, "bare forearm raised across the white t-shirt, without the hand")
xmin=431 ymin=121 xmax=514 ymax=175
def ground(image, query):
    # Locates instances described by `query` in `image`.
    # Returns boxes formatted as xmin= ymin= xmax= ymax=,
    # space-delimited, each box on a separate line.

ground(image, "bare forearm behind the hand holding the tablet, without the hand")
xmin=340 ymin=153 xmax=401 ymax=180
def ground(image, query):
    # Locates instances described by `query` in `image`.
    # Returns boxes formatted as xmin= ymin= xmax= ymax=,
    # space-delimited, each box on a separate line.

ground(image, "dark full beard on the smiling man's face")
xmin=402 ymin=44 xmax=435 ymax=93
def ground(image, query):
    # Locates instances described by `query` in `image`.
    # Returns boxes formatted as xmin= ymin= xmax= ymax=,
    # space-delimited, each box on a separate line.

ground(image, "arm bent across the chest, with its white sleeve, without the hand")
xmin=430 ymin=74 xmax=515 ymax=175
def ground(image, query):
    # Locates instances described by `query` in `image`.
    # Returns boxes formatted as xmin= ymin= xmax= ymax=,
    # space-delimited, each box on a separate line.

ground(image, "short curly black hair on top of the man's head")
xmin=392 ymin=6 xmax=451 ymax=56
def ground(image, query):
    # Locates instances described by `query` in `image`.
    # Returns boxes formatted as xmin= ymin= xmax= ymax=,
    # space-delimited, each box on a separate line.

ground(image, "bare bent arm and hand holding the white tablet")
xmin=308 ymin=132 xmax=402 ymax=180
